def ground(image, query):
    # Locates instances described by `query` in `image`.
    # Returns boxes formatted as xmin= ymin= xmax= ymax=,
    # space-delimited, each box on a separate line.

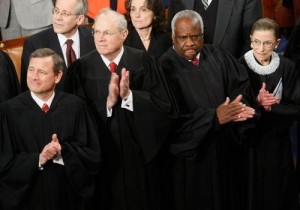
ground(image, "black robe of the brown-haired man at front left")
xmin=0 ymin=91 xmax=100 ymax=210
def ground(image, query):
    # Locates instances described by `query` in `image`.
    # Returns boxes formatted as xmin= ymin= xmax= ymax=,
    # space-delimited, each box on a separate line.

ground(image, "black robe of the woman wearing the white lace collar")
xmin=240 ymin=55 xmax=300 ymax=210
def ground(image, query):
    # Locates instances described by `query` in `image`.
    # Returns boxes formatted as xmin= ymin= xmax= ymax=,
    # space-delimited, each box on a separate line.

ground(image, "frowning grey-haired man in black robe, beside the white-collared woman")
xmin=159 ymin=10 xmax=256 ymax=210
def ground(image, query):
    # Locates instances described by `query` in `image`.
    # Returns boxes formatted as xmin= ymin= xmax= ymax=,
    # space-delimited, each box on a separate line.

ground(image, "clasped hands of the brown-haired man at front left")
xmin=39 ymin=134 xmax=61 ymax=165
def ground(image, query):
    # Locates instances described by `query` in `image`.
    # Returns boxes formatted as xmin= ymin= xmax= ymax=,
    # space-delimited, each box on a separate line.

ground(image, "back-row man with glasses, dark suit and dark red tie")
xmin=21 ymin=0 xmax=95 ymax=91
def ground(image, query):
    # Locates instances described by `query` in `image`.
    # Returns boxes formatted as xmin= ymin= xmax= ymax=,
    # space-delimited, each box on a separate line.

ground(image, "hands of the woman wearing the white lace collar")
xmin=257 ymin=82 xmax=279 ymax=111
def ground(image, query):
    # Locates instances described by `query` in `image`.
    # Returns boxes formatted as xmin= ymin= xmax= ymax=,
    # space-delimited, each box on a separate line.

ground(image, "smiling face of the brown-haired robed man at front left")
xmin=27 ymin=56 xmax=62 ymax=98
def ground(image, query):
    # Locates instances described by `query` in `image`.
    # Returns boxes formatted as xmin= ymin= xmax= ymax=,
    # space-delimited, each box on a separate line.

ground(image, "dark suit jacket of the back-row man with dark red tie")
xmin=21 ymin=27 xmax=95 ymax=91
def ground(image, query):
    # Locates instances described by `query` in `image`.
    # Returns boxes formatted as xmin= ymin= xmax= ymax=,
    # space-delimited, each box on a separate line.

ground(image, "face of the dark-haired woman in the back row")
xmin=130 ymin=0 xmax=155 ymax=30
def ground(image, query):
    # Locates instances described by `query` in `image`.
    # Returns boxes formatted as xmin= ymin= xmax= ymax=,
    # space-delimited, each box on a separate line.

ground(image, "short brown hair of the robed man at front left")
xmin=29 ymin=48 xmax=64 ymax=74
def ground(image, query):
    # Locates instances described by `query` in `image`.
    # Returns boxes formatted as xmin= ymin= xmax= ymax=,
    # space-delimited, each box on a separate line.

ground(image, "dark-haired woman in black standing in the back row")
xmin=124 ymin=0 xmax=172 ymax=58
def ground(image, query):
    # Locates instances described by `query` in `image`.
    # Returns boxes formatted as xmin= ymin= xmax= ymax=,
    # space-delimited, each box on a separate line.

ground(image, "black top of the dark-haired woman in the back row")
xmin=124 ymin=28 xmax=172 ymax=58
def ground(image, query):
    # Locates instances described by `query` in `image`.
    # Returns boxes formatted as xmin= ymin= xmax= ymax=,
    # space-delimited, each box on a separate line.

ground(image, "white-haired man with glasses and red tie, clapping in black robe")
xmin=65 ymin=8 xmax=172 ymax=210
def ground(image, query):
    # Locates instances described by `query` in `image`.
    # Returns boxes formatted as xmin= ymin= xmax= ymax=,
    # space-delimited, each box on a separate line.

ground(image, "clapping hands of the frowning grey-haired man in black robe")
xmin=217 ymin=95 xmax=255 ymax=125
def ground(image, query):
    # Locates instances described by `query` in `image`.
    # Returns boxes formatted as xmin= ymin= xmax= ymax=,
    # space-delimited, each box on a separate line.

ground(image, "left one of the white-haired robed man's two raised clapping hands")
xmin=106 ymin=73 xmax=119 ymax=109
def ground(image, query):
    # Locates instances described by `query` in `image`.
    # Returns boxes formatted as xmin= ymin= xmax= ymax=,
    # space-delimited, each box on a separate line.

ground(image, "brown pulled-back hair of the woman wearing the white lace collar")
xmin=251 ymin=18 xmax=279 ymax=39
